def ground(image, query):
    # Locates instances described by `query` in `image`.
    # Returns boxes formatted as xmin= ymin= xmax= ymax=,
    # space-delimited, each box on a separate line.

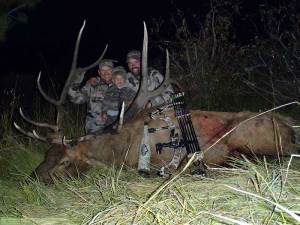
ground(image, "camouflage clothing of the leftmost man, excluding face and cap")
xmin=68 ymin=76 xmax=112 ymax=134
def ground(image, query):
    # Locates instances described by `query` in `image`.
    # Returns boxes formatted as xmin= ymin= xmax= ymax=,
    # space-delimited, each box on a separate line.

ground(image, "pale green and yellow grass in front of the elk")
xmin=0 ymin=98 xmax=300 ymax=225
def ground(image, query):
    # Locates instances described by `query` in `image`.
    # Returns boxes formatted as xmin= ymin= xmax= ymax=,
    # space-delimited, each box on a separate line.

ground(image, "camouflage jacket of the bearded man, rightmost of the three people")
xmin=125 ymin=68 xmax=174 ymax=106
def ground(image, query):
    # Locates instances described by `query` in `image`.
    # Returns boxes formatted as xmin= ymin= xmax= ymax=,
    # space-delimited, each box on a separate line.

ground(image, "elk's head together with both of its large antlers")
xmin=14 ymin=23 xmax=175 ymax=183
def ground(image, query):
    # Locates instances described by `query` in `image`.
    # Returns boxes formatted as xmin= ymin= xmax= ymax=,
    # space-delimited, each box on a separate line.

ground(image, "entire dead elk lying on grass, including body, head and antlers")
xmin=15 ymin=21 xmax=299 ymax=183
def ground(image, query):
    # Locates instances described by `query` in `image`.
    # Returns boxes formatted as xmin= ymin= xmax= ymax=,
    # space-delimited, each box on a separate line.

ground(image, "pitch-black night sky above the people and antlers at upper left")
xmin=0 ymin=0 xmax=276 ymax=100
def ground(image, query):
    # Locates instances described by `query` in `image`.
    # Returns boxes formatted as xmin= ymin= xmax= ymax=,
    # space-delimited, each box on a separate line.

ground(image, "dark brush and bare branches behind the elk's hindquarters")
xmin=152 ymin=0 xmax=300 ymax=111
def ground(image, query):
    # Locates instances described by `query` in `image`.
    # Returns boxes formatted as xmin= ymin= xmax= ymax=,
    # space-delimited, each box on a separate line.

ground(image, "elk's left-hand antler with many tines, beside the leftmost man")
xmin=14 ymin=20 xmax=108 ymax=144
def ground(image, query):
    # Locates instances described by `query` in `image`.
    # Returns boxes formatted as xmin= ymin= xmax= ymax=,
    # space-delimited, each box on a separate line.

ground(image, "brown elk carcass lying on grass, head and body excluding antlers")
xmin=35 ymin=110 xmax=299 ymax=182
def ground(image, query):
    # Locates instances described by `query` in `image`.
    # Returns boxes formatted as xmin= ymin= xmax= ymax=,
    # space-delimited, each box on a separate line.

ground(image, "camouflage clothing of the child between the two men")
xmin=103 ymin=84 xmax=136 ymax=126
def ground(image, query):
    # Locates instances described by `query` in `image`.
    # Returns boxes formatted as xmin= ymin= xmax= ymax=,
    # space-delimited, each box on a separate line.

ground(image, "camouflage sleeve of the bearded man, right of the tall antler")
xmin=150 ymin=69 xmax=174 ymax=106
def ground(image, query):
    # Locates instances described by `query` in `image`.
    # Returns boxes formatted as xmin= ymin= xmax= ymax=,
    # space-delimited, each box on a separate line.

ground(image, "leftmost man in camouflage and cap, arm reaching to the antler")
xmin=68 ymin=59 xmax=114 ymax=134
